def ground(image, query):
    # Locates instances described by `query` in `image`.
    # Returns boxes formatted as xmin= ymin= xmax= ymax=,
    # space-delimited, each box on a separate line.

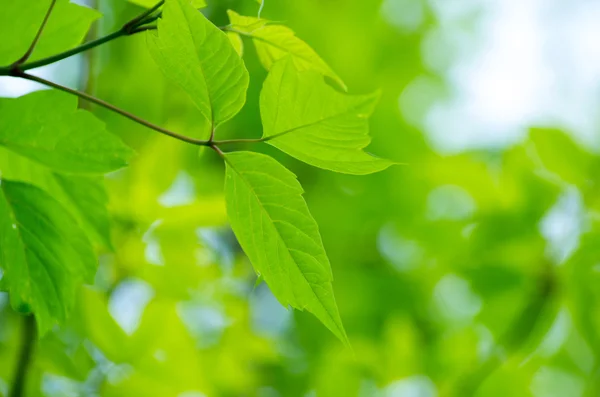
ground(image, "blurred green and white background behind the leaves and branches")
xmin=0 ymin=0 xmax=600 ymax=397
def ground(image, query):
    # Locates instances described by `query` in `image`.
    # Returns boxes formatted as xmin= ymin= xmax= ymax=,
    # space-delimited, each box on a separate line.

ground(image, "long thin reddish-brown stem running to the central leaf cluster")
xmin=13 ymin=72 xmax=212 ymax=146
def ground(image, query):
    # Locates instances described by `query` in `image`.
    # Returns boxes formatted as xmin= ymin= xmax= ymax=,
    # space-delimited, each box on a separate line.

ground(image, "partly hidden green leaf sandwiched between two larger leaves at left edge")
xmin=0 ymin=147 xmax=112 ymax=248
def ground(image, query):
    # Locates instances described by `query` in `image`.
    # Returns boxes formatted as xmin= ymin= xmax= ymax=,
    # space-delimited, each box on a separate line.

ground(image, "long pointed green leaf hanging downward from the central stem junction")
xmin=225 ymin=152 xmax=348 ymax=344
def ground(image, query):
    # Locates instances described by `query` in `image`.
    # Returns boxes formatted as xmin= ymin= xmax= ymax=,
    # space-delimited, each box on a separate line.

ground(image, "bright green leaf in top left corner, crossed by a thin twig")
xmin=0 ymin=0 xmax=101 ymax=66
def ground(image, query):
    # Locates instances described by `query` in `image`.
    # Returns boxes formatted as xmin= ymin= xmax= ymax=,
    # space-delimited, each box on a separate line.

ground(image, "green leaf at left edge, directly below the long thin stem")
xmin=0 ymin=90 xmax=132 ymax=174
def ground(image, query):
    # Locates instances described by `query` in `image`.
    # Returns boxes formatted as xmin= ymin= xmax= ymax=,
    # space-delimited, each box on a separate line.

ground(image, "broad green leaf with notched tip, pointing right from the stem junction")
xmin=260 ymin=57 xmax=394 ymax=175
